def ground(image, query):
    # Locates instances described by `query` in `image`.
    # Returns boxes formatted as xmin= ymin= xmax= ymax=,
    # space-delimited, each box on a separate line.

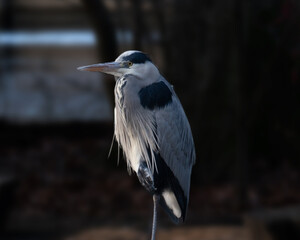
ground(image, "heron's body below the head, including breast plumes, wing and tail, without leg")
xmin=115 ymin=76 xmax=195 ymax=223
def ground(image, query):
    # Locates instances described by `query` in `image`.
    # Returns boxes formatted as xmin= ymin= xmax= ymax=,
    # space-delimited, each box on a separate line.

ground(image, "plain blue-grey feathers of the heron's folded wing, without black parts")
xmin=155 ymin=81 xmax=196 ymax=199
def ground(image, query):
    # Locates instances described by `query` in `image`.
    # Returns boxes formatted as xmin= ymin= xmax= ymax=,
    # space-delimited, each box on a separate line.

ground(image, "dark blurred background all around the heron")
xmin=0 ymin=0 xmax=300 ymax=240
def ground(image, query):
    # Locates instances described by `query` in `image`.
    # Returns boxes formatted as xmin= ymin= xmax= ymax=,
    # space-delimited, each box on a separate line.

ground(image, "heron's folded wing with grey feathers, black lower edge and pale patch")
xmin=154 ymin=78 xmax=195 ymax=223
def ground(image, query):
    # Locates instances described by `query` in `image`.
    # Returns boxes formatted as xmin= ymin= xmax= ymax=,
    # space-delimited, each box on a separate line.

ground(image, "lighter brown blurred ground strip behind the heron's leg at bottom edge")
xmin=63 ymin=220 xmax=272 ymax=240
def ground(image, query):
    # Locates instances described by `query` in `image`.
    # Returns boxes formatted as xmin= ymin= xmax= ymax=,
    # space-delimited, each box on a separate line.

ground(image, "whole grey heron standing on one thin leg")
xmin=78 ymin=51 xmax=196 ymax=240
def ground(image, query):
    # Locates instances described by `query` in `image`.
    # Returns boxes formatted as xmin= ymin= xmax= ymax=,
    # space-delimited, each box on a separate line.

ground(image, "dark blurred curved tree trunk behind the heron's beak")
xmin=82 ymin=0 xmax=118 ymax=103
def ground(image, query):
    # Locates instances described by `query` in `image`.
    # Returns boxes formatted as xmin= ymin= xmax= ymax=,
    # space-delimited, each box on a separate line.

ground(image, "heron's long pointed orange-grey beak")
xmin=77 ymin=62 xmax=124 ymax=75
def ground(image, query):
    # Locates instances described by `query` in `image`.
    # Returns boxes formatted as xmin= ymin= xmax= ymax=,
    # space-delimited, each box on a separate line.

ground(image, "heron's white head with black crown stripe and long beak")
xmin=78 ymin=50 xmax=160 ymax=82
